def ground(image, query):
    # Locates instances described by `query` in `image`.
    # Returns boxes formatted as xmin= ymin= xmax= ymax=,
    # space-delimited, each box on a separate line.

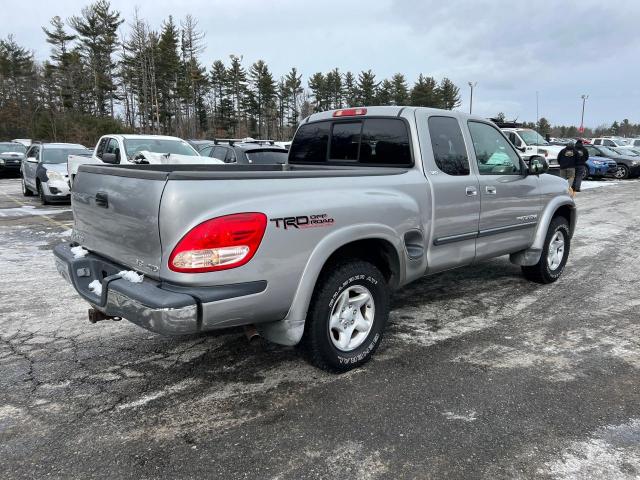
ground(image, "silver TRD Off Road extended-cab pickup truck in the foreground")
xmin=54 ymin=107 xmax=576 ymax=371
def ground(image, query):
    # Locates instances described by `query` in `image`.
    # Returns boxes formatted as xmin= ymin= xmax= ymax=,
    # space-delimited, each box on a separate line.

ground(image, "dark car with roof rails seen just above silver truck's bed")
xmin=200 ymin=140 xmax=288 ymax=165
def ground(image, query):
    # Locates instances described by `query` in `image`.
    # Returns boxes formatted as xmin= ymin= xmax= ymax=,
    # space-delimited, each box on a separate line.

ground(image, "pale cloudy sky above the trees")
xmin=5 ymin=0 xmax=640 ymax=126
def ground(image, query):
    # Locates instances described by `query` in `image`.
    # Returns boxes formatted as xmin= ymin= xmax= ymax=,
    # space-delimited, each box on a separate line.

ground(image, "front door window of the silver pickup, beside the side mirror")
xmin=469 ymin=122 xmax=522 ymax=175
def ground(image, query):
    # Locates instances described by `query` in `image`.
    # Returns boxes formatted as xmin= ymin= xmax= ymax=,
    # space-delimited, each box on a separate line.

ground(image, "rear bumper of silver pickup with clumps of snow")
xmin=53 ymin=244 xmax=267 ymax=335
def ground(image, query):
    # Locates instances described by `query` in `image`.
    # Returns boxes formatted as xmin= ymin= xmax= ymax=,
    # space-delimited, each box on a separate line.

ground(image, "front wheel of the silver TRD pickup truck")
xmin=522 ymin=217 xmax=571 ymax=283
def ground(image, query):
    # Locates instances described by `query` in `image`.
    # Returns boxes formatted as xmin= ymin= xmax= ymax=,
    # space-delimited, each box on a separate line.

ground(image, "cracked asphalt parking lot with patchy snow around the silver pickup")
xmin=0 ymin=179 xmax=640 ymax=480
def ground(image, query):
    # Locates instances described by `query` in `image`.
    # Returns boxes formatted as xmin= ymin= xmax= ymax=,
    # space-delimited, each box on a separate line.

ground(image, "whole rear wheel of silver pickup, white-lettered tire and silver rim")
xmin=302 ymin=260 xmax=389 ymax=372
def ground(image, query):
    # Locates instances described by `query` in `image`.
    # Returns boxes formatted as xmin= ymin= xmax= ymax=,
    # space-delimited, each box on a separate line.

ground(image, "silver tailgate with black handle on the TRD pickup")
xmin=71 ymin=166 xmax=168 ymax=278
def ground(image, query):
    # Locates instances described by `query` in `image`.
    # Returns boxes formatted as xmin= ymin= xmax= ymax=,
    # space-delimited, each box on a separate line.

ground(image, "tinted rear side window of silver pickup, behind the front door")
xmin=428 ymin=117 xmax=469 ymax=176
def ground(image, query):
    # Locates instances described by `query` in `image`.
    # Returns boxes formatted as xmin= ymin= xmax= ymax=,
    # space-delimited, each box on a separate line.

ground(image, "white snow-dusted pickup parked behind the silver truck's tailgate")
xmin=67 ymin=135 xmax=218 ymax=185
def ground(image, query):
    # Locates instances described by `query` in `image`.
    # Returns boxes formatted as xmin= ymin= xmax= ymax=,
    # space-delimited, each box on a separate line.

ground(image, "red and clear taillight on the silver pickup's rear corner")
xmin=169 ymin=213 xmax=267 ymax=273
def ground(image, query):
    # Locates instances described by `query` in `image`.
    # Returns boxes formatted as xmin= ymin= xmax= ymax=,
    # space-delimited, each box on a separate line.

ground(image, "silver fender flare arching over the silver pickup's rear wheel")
xmin=256 ymin=224 xmax=406 ymax=346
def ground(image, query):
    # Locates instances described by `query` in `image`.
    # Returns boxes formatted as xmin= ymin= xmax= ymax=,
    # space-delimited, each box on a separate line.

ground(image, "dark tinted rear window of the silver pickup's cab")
xmin=289 ymin=118 xmax=413 ymax=167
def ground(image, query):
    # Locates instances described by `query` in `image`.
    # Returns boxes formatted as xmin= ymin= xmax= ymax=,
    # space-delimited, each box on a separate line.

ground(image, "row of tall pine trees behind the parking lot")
xmin=0 ymin=0 xmax=460 ymax=145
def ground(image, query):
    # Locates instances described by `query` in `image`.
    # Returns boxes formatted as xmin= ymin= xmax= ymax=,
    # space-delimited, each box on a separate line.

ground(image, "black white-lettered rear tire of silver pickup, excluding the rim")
xmin=301 ymin=259 xmax=389 ymax=373
